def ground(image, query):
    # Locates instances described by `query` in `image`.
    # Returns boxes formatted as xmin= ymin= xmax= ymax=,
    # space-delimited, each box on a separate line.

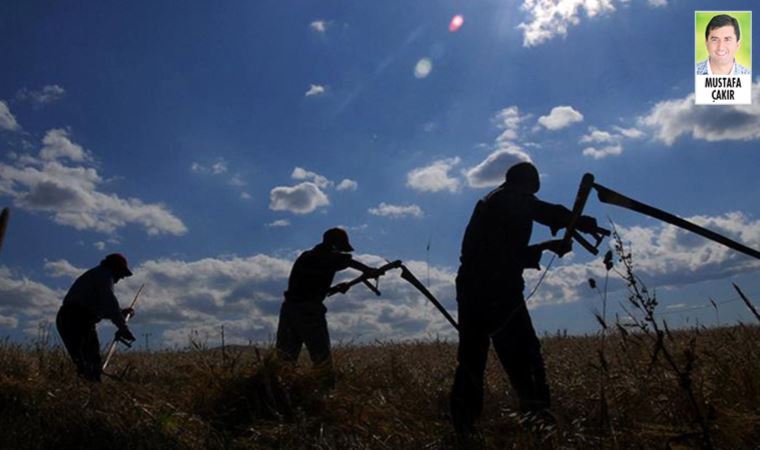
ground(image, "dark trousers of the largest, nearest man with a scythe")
xmin=451 ymin=296 xmax=550 ymax=431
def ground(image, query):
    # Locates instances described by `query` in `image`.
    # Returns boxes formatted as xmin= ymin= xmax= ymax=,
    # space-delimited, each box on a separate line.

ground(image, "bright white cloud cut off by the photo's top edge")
xmin=517 ymin=0 xmax=616 ymax=47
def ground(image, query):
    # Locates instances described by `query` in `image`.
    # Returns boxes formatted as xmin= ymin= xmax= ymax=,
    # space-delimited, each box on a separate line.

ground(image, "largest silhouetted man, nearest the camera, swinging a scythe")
xmin=451 ymin=162 xmax=597 ymax=434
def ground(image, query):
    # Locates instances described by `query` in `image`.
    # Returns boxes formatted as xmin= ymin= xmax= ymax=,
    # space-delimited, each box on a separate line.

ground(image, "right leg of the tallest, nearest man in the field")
xmin=493 ymin=300 xmax=550 ymax=411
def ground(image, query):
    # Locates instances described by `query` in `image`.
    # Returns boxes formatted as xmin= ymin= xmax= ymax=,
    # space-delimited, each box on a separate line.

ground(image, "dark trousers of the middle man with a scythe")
xmin=276 ymin=301 xmax=332 ymax=369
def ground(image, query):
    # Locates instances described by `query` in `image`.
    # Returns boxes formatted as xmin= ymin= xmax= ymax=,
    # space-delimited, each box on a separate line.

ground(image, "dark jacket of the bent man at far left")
xmin=63 ymin=266 xmax=126 ymax=329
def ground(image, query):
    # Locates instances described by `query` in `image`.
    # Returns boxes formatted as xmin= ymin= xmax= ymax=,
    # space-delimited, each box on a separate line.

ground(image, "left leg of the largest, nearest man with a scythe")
xmin=450 ymin=303 xmax=489 ymax=434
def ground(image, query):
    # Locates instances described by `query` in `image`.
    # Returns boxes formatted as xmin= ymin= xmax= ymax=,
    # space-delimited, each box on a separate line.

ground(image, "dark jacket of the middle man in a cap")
xmin=285 ymin=244 xmax=352 ymax=303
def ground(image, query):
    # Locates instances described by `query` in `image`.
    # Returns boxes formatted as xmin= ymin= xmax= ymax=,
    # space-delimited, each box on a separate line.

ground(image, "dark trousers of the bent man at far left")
xmin=55 ymin=305 xmax=102 ymax=381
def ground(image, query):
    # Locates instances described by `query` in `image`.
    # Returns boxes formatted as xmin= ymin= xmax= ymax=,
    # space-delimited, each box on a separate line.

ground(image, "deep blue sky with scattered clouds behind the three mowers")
xmin=0 ymin=0 xmax=760 ymax=346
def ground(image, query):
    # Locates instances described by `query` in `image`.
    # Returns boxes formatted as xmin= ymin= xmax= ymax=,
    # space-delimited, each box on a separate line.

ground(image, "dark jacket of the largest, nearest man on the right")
xmin=457 ymin=184 xmax=572 ymax=295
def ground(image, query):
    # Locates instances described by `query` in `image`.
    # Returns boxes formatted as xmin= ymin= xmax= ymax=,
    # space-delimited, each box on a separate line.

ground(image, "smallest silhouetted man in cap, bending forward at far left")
xmin=55 ymin=253 xmax=135 ymax=382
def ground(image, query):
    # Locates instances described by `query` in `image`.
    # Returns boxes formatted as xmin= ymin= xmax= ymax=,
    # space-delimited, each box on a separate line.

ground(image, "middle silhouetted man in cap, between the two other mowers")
xmin=276 ymin=228 xmax=380 ymax=372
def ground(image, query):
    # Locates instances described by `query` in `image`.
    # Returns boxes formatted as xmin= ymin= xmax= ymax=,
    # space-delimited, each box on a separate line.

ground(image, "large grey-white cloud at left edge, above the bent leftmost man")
xmin=0 ymin=130 xmax=187 ymax=235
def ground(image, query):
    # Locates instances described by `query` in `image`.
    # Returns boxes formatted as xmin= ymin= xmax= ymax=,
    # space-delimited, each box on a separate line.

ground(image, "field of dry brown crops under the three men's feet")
xmin=0 ymin=320 xmax=760 ymax=449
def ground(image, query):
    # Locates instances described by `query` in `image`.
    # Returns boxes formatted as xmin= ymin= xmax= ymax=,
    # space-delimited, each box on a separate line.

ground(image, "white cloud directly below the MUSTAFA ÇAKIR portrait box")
xmin=639 ymin=80 xmax=760 ymax=145
